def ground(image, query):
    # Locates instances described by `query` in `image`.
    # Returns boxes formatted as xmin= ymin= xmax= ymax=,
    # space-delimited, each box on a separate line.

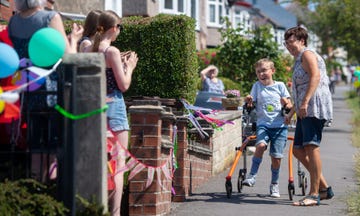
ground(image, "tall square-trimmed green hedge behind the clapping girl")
xmin=114 ymin=14 xmax=199 ymax=102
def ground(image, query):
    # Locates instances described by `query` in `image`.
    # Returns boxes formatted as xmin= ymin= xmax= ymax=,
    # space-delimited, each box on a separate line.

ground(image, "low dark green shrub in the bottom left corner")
xmin=0 ymin=179 xmax=68 ymax=216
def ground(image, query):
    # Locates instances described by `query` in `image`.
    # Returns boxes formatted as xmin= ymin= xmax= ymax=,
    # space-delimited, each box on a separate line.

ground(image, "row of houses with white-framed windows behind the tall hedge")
xmin=55 ymin=0 xmax=297 ymax=49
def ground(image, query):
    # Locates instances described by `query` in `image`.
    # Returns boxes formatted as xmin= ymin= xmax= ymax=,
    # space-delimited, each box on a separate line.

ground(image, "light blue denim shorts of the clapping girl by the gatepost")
xmin=106 ymin=90 xmax=130 ymax=132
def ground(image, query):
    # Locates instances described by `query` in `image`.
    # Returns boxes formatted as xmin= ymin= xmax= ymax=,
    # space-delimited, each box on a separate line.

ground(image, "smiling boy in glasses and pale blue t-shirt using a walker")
xmin=243 ymin=58 xmax=292 ymax=198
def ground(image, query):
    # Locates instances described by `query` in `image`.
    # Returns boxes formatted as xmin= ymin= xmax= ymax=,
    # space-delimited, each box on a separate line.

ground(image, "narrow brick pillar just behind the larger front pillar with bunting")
xmin=173 ymin=117 xmax=190 ymax=202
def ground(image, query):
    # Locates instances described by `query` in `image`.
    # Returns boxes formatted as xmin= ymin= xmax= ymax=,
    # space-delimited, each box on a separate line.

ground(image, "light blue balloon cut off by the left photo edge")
xmin=0 ymin=43 xmax=20 ymax=78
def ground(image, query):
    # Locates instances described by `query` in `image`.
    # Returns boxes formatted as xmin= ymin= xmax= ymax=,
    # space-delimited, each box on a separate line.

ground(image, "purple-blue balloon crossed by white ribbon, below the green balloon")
xmin=12 ymin=69 xmax=45 ymax=91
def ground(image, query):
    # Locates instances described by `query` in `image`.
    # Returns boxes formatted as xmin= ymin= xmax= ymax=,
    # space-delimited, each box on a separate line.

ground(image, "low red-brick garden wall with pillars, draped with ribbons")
xmin=129 ymin=100 xmax=241 ymax=215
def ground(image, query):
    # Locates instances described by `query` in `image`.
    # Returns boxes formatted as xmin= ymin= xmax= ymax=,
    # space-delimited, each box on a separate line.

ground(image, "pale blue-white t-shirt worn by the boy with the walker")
xmin=250 ymin=81 xmax=290 ymax=128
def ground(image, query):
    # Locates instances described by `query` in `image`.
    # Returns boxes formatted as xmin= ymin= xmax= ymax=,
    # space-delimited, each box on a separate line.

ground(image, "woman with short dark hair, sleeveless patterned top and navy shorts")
xmin=284 ymin=27 xmax=334 ymax=206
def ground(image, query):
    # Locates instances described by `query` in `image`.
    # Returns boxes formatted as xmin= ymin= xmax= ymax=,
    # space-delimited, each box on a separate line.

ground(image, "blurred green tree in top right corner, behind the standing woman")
xmin=291 ymin=0 xmax=360 ymax=62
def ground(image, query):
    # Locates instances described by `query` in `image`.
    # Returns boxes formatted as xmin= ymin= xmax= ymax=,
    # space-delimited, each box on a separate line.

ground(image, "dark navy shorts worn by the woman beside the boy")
xmin=294 ymin=117 xmax=326 ymax=148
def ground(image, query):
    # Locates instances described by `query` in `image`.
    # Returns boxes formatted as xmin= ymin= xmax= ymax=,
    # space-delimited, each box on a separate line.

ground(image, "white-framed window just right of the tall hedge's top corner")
xmin=207 ymin=0 xmax=226 ymax=27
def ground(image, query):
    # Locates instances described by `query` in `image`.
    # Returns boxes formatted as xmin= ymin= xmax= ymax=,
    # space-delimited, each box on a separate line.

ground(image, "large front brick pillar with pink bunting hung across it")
xmin=129 ymin=101 xmax=171 ymax=215
